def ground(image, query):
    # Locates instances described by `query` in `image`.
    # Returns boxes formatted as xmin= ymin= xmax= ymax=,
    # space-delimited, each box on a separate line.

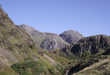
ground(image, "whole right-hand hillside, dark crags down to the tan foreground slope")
xmin=67 ymin=35 xmax=110 ymax=75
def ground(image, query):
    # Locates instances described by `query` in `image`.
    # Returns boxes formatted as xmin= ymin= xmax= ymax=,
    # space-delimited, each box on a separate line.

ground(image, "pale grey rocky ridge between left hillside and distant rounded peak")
xmin=19 ymin=25 xmax=69 ymax=50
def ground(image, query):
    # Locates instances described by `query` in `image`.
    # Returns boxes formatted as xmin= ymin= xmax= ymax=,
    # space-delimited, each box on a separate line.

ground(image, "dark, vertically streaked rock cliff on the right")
xmin=71 ymin=35 xmax=110 ymax=56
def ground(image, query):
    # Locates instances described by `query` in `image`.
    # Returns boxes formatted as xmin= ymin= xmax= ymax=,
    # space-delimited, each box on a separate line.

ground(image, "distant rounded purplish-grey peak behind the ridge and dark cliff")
xmin=60 ymin=30 xmax=83 ymax=44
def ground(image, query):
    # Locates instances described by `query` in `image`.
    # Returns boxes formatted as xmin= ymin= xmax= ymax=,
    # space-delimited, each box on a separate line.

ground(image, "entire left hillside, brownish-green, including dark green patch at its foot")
xmin=0 ymin=8 xmax=65 ymax=75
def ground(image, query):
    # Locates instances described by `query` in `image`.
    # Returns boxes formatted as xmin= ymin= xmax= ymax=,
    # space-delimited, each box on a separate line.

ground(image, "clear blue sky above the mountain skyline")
xmin=0 ymin=0 xmax=110 ymax=36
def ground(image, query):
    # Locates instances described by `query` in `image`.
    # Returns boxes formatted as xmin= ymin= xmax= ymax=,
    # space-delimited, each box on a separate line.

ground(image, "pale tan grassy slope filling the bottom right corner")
xmin=73 ymin=58 xmax=110 ymax=75
